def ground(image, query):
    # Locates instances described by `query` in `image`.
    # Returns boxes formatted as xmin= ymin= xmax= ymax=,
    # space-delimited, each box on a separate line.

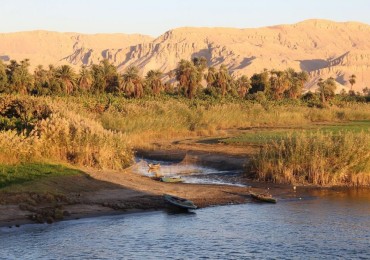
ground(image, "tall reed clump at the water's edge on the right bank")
xmin=252 ymin=131 xmax=370 ymax=186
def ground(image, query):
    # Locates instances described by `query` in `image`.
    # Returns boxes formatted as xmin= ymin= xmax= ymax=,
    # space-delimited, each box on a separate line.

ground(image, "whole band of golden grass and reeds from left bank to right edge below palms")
xmin=0 ymin=95 xmax=370 ymax=172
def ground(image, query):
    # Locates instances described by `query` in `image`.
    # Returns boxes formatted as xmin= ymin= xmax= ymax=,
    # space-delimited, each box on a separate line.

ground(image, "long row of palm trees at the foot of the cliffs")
xmin=0 ymin=57 xmax=369 ymax=102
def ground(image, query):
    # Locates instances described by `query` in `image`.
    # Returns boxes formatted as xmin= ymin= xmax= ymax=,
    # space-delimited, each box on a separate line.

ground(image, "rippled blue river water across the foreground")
xmin=0 ymin=161 xmax=370 ymax=259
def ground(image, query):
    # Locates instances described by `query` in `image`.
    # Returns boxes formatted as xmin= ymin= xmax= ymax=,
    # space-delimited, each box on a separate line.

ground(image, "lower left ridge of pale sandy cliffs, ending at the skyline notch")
xmin=0 ymin=31 xmax=153 ymax=68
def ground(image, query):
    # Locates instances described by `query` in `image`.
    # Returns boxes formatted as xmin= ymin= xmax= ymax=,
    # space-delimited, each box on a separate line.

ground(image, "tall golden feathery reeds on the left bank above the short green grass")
xmin=0 ymin=96 xmax=133 ymax=169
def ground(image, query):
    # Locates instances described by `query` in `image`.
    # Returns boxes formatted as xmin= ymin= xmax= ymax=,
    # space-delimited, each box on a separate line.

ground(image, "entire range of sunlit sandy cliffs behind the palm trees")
xmin=0 ymin=20 xmax=370 ymax=90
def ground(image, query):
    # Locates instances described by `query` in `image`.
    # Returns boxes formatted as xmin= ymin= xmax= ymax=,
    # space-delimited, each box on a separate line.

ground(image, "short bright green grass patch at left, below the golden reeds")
xmin=0 ymin=163 xmax=82 ymax=189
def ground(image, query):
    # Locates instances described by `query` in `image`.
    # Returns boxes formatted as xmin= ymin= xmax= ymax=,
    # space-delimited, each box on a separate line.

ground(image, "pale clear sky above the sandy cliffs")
xmin=0 ymin=0 xmax=370 ymax=36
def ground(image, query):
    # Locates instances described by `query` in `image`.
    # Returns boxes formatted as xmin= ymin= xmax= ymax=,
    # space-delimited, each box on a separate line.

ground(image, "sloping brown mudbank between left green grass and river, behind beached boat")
xmin=0 ymin=152 xmax=260 ymax=226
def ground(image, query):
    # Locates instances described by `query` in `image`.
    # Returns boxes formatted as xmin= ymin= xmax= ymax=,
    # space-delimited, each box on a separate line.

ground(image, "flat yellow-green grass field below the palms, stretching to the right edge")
xmin=96 ymin=99 xmax=370 ymax=147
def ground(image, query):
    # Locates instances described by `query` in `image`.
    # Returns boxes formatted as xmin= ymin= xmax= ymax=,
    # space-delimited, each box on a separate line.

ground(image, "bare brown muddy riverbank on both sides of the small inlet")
xmin=0 ymin=127 xmax=368 ymax=227
